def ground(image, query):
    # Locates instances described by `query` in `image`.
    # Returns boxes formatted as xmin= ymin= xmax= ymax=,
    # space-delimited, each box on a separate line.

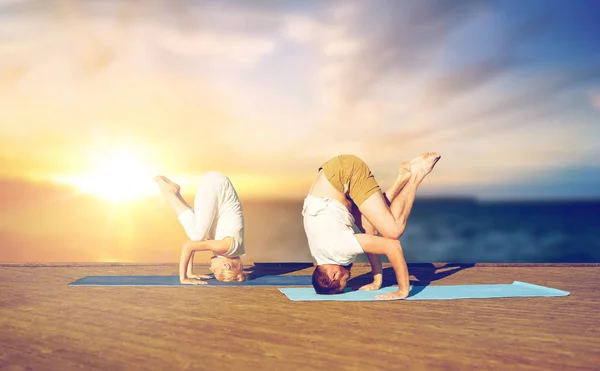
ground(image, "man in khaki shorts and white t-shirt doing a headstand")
xmin=302 ymin=152 xmax=441 ymax=300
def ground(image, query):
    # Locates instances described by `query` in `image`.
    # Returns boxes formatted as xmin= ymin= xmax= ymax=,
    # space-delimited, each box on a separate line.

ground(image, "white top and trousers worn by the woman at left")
xmin=178 ymin=171 xmax=245 ymax=256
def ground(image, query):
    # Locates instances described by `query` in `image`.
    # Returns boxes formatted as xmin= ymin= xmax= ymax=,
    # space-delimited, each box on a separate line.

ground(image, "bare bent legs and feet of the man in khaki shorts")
xmin=359 ymin=153 xmax=440 ymax=240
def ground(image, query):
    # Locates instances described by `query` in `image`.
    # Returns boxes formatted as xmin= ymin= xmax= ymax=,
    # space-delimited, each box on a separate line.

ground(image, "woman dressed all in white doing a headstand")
xmin=154 ymin=171 xmax=246 ymax=285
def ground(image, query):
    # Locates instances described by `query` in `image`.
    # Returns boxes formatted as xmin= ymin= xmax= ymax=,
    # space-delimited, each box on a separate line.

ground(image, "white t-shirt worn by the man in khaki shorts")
xmin=302 ymin=195 xmax=364 ymax=265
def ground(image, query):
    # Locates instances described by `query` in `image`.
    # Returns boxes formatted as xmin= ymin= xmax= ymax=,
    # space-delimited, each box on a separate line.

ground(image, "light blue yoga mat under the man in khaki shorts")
xmin=279 ymin=281 xmax=569 ymax=301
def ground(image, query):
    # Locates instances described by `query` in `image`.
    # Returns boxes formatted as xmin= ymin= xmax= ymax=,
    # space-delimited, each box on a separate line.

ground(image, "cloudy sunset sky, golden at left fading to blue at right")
xmin=0 ymin=0 xmax=600 ymax=264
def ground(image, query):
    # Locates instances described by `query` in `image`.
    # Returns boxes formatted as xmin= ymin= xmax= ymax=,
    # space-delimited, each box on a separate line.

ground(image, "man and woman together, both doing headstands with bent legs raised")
xmin=154 ymin=152 xmax=441 ymax=299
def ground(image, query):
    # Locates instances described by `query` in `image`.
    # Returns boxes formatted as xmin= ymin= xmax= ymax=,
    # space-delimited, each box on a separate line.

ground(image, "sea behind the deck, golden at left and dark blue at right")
xmin=0 ymin=179 xmax=600 ymax=263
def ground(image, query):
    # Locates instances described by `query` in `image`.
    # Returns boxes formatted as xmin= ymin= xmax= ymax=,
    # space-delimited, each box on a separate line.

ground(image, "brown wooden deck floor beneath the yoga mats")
xmin=0 ymin=265 xmax=600 ymax=371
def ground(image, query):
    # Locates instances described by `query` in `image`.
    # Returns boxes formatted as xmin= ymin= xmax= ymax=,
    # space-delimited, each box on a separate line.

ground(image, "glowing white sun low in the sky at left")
xmin=59 ymin=149 xmax=157 ymax=202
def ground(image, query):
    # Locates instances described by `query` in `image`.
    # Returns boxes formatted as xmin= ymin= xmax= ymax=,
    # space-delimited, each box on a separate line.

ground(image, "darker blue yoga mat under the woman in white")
xmin=69 ymin=276 xmax=312 ymax=286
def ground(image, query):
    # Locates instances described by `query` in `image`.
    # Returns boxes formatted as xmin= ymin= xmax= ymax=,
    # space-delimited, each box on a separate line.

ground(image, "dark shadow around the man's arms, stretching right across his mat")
xmin=348 ymin=263 xmax=475 ymax=291
